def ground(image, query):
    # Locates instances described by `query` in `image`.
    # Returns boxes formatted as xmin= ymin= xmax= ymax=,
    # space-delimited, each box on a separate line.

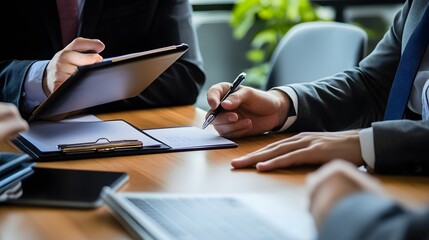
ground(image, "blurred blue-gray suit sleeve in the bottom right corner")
xmin=318 ymin=193 xmax=429 ymax=240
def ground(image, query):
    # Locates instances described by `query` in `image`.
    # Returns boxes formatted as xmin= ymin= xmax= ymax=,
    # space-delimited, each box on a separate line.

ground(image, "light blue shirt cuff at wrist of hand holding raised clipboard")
xmin=24 ymin=60 xmax=49 ymax=112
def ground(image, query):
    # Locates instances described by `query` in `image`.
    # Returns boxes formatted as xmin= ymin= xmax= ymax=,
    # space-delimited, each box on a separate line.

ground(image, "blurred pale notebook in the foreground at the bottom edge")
xmin=103 ymin=189 xmax=314 ymax=240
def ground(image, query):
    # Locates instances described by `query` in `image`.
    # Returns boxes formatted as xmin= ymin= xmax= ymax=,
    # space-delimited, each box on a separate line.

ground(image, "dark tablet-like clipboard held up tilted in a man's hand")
xmin=29 ymin=43 xmax=188 ymax=121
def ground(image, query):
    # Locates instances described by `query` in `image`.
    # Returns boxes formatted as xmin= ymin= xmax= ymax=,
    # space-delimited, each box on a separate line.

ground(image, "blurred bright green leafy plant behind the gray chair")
xmin=231 ymin=0 xmax=328 ymax=87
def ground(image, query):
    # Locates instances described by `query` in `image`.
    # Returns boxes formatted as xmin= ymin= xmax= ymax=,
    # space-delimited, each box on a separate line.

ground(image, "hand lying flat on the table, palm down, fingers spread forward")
xmin=231 ymin=130 xmax=364 ymax=171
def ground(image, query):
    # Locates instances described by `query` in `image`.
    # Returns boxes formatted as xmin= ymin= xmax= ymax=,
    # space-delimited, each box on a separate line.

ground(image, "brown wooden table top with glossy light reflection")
xmin=0 ymin=106 xmax=429 ymax=239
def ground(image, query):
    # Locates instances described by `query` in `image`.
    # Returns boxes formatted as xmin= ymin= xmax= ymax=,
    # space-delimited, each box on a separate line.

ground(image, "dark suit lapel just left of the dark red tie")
xmin=37 ymin=0 xmax=63 ymax=52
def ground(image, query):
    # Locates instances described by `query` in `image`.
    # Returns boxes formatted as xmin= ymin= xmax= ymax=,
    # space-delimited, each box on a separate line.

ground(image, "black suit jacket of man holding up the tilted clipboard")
xmin=0 ymin=0 xmax=205 ymax=117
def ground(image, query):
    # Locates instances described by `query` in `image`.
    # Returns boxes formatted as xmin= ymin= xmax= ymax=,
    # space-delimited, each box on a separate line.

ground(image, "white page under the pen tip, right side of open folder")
xmin=144 ymin=126 xmax=237 ymax=150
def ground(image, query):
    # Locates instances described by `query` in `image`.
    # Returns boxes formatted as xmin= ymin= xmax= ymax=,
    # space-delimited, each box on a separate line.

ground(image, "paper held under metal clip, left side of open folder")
xmin=20 ymin=120 xmax=161 ymax=152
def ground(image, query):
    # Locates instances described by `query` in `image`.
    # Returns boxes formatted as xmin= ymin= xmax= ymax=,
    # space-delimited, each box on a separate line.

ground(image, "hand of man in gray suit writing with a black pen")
xmin=207 ymin=83 xmax=290 ymax=138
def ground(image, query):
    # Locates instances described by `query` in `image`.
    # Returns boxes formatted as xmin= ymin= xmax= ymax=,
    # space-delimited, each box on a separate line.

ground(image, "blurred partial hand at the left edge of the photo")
xmin=0 ymin=103 xmax=28 ymax=141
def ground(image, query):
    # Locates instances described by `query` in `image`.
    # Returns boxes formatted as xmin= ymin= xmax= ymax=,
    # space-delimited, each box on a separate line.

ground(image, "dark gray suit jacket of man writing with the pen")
xmin=289 ymin=0 xmax=429 ymax=174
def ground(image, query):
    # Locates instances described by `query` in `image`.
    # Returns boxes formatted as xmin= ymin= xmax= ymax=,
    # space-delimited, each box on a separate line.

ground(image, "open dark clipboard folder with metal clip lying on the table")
xmin=12 ymin=120 xmax=237 ymax=161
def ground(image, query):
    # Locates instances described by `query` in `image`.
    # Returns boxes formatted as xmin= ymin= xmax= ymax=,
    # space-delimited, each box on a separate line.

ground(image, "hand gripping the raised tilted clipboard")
xmin=43 ymin=38 xmax=104 ymax=96
